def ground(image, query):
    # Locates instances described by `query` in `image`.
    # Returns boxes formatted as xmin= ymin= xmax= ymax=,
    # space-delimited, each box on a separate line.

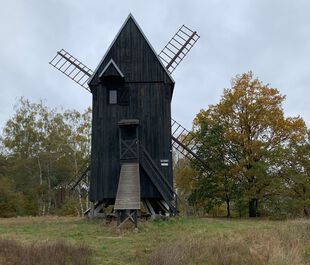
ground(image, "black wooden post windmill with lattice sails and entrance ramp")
xmin=50 ymin=14 xmax=207 ymax=226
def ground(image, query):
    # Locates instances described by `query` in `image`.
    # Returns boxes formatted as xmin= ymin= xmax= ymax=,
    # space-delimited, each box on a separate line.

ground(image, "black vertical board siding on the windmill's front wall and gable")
xmin=90 ymin=16 xmax=174 ymax=201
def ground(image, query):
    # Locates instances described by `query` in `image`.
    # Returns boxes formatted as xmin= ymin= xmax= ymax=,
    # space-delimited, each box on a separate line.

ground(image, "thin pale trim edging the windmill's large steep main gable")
xmin=87 ymin=13 xmax=174 ymax=85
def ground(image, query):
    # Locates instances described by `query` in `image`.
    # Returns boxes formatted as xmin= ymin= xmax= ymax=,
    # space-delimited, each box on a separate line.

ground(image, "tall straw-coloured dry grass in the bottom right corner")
xmin=149 ymin=219 xmax=310 ymax=265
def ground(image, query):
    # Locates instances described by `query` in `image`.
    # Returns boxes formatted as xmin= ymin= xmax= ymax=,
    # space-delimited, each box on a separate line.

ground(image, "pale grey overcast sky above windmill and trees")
xmin=0 ymin=0 xmax=310 ymax=128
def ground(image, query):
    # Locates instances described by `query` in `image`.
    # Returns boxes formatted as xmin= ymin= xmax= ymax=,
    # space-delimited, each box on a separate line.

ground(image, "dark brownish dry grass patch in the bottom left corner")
xmin=0 ymin=239 xmax=91 ymax=265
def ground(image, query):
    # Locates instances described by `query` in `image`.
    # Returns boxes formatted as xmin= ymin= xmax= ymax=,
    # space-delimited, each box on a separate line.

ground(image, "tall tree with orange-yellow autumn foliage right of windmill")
xmin=193 ymin=72 xmax=306 ymax=217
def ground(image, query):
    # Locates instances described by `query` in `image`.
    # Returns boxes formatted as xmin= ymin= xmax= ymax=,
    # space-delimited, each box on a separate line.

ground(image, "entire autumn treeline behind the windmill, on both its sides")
xmin=0 ymin=72 xmax=310 ymax=218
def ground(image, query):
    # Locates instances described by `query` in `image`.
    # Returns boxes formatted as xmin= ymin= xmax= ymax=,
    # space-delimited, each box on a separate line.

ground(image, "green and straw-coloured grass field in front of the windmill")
xmin=0 ymin=217 xmax=310 ymax=265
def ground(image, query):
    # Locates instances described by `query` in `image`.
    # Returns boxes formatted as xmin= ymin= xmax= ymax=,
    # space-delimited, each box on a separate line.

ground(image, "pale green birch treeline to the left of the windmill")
xmin=0 ymin=98 xmax=91 ymax=217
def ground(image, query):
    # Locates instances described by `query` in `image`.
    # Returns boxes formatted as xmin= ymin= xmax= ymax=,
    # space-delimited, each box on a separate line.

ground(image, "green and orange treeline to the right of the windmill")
xmin=175 ymin=72 xmax=310 ymax=218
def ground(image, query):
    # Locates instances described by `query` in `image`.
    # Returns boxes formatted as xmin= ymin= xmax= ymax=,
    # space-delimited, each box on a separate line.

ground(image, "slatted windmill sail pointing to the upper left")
xmin=49 ymin=49 xmax=93 ymax=92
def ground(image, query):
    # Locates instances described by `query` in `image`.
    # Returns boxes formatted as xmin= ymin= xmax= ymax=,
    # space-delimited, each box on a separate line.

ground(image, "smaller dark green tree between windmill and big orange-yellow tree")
xmin=190 ymin=124 xmax=240 ymax=217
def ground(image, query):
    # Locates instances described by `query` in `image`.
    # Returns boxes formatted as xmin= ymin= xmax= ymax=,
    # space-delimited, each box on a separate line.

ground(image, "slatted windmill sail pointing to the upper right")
xmin=158 ymin=25 xmax=200 ymax=74
